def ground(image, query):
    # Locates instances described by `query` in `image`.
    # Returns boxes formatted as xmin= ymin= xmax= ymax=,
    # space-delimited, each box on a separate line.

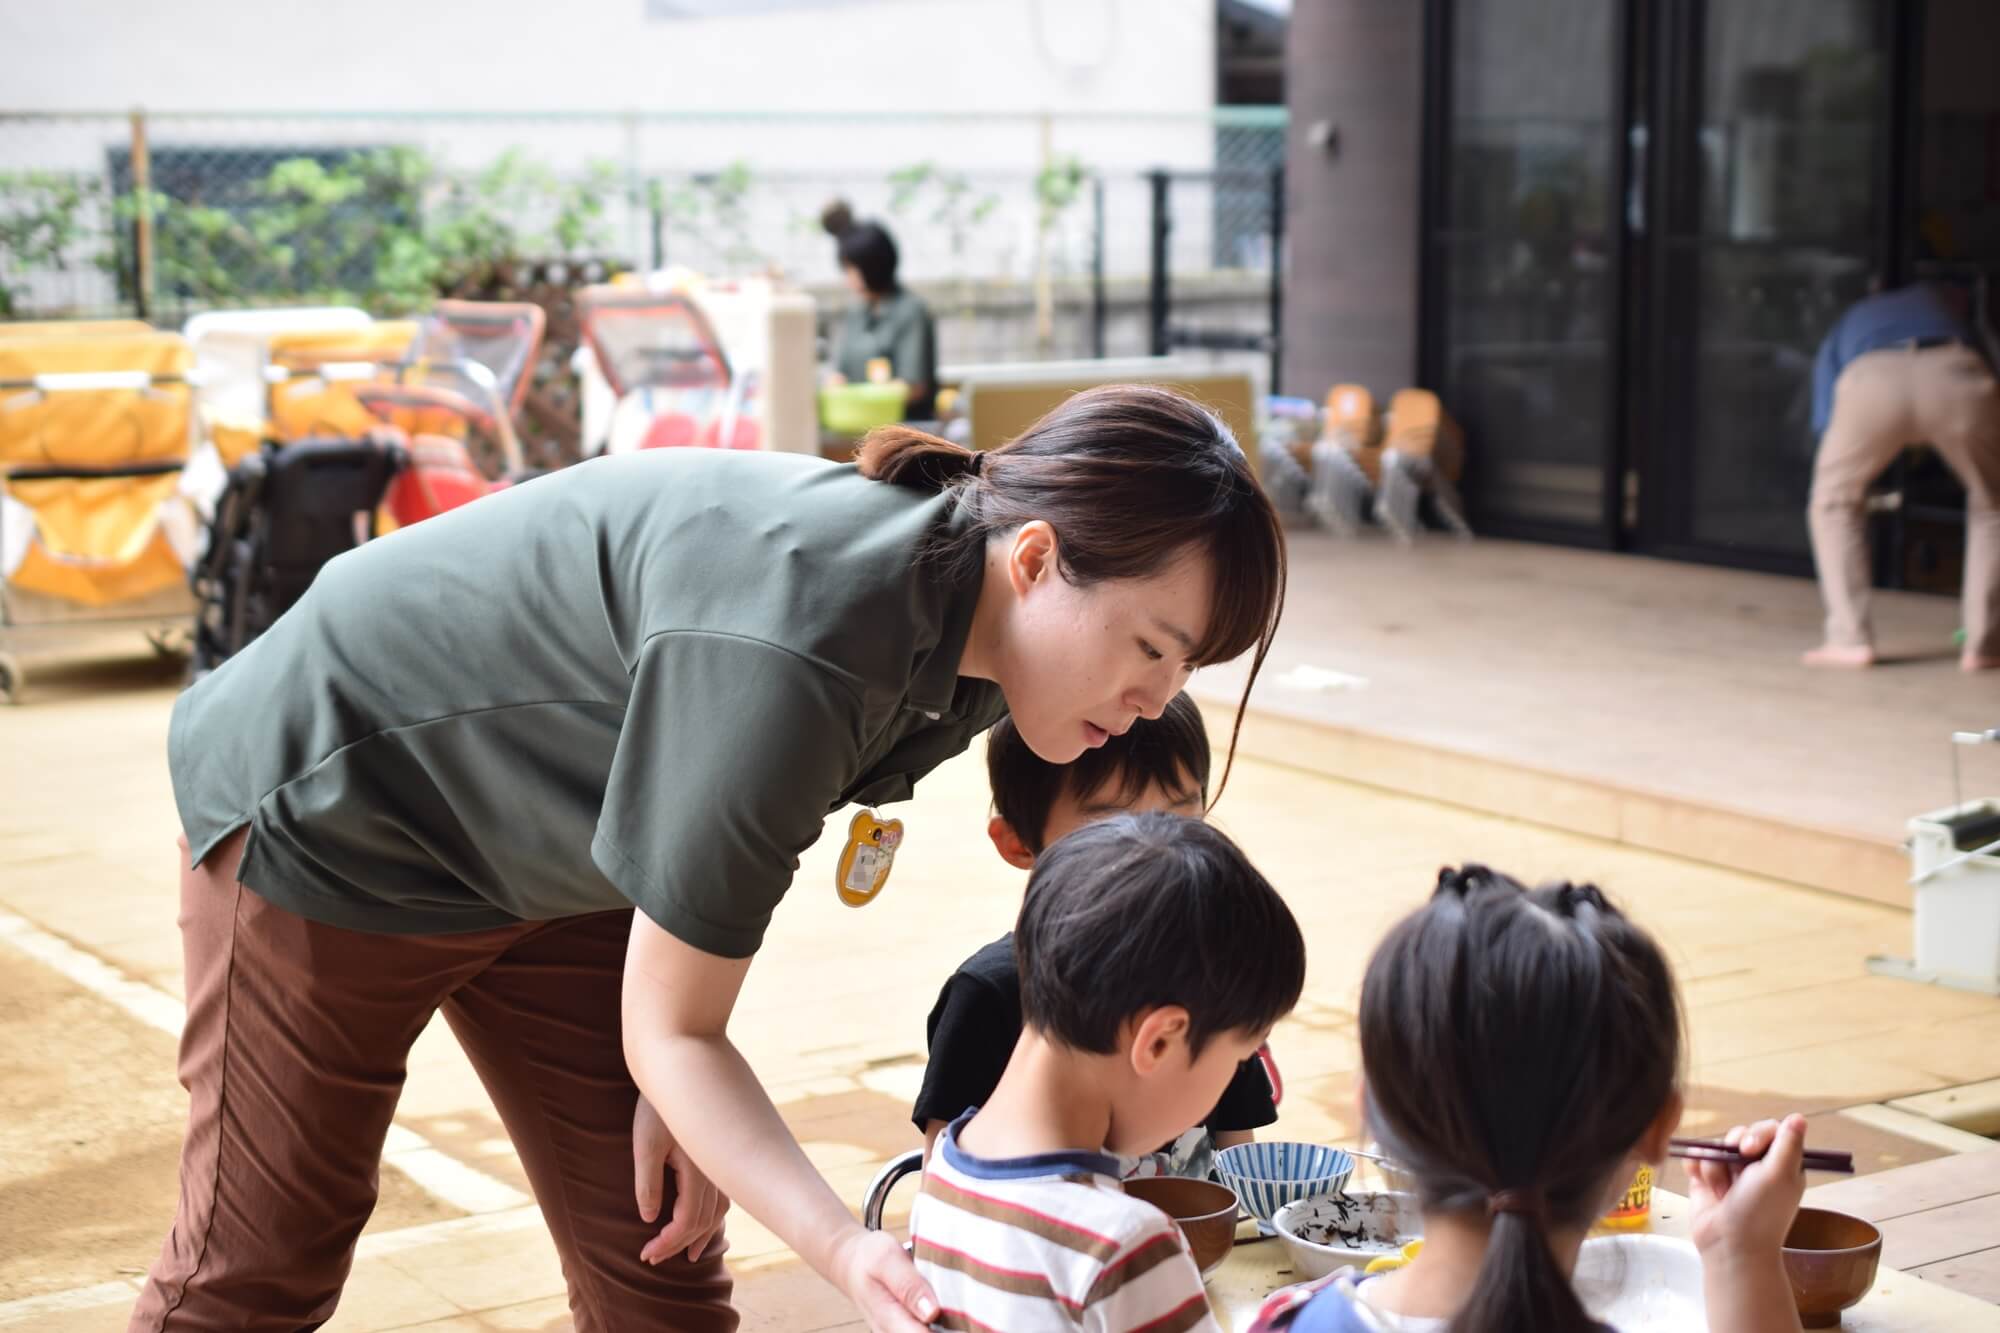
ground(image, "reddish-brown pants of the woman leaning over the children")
xmin=130 ymin=833 xmax=736 ymax=1333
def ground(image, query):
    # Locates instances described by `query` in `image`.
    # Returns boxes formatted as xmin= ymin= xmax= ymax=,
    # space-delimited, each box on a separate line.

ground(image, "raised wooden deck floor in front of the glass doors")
xmin=1196 ymin=532 xmax=2000 ymax=903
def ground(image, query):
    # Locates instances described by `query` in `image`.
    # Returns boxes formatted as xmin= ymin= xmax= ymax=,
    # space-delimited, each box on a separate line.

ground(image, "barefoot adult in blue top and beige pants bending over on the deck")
xmin=1806 ymin=282 xmax=2000 ymax=671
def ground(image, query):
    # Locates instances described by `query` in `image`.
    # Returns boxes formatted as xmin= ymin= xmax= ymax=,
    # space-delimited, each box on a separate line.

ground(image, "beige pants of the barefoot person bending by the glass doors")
xmin=1806 ymin=344 xmax=2000 ymax=656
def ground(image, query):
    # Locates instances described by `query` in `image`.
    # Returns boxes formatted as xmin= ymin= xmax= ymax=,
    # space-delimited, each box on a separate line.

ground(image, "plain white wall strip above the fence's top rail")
xmin=0 ymin=0 xmax=1214 ymax=114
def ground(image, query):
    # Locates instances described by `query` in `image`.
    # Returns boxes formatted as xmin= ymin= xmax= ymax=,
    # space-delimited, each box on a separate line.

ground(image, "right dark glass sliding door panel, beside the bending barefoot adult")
xmin=1638 ymin=0 xmax=1892 ymax=570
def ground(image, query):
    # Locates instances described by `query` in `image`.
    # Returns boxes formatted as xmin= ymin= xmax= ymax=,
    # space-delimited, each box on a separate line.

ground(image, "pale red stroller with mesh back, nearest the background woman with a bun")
xmin=576 ymin=286 xmax=762 ymax=456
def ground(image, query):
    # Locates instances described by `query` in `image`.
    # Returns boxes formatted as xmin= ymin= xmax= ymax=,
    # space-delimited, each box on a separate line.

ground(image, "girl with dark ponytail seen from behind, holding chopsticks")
xmin=1254 ymin=867 xmax=1806 ymax=1333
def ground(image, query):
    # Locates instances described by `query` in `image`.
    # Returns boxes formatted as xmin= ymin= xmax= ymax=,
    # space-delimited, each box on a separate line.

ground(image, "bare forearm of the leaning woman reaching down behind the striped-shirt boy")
xmin=622 ymin=913 xmax=938 ymax=1333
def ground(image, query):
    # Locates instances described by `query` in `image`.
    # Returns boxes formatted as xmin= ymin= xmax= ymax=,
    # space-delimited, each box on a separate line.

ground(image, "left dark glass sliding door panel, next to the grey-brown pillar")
xmin=1426 ymin=0 xmax=1624 ymax=544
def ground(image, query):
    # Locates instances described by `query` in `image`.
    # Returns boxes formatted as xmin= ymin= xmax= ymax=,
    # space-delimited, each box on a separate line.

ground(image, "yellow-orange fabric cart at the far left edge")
xmin=0 ymin=320 xmax=196 ymax=701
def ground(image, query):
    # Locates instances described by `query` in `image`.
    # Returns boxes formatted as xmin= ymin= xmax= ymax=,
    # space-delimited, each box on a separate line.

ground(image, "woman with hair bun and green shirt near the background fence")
xmin=820 ymin=200 xmax=938 ymax=420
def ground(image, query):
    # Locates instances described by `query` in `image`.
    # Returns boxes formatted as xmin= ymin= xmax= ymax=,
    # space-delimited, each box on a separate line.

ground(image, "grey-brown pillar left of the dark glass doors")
xmin=1282 ymin=0 xmax=1426 ymax=398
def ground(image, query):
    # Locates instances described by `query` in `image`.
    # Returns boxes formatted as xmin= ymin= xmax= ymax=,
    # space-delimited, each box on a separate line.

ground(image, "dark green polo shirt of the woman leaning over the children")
xmin=168 ymin=448 xmax=1006 ymax=957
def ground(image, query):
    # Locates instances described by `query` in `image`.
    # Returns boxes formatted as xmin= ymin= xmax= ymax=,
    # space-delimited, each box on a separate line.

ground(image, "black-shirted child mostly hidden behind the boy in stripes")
xmin=910 ymin=693 xmax=1278 ymax=1177
